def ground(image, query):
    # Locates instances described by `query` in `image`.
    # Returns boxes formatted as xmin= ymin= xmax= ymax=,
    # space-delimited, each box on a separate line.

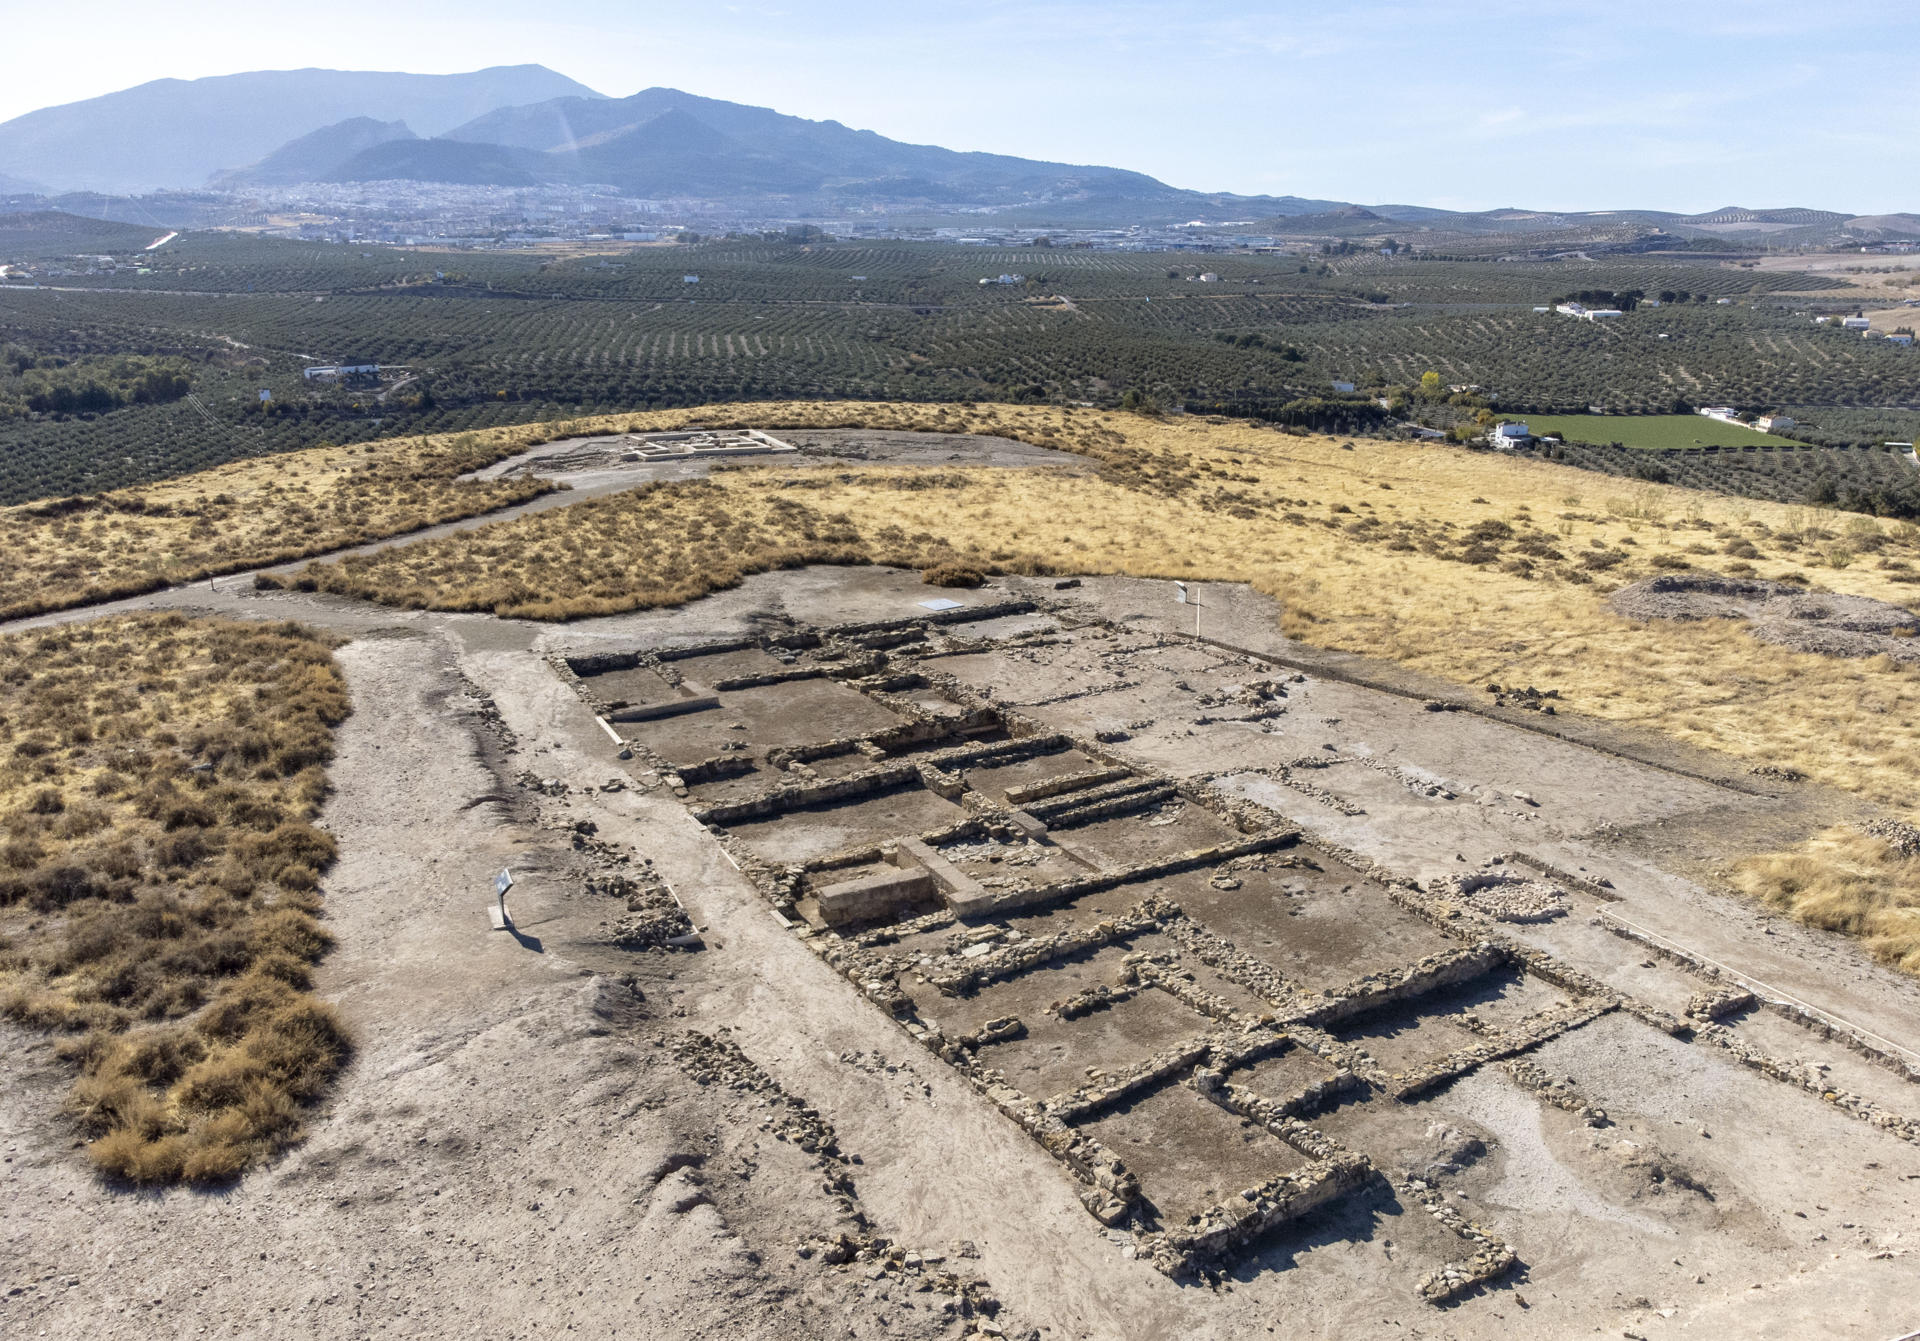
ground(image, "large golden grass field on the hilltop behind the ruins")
xmin=280 ymin=403 xmax=1920 ymax=805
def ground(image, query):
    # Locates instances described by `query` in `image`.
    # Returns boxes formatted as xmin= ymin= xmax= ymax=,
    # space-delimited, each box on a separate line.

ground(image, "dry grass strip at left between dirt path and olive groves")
xmin=0 ymin=407 xmax=668 ymax=619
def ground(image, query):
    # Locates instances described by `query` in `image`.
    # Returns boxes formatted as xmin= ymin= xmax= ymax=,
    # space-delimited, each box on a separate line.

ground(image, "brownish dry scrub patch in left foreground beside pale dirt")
xmin=0 ymin=615 xmax=348 ymax=1183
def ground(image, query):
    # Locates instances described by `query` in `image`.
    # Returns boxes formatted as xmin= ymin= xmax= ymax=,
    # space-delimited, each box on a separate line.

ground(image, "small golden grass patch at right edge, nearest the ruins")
xmin=1734 ymin=826 xmax=1920 ymax=974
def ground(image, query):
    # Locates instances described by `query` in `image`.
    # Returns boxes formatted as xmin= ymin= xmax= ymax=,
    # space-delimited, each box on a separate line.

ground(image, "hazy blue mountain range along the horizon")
xmin=0 ymin=65 xmax=1920 ymax=244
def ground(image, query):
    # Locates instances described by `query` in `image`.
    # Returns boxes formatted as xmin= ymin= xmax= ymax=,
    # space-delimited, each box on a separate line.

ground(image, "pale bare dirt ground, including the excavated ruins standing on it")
xmin=0 ymin=567 xmax=1920 ymax=1341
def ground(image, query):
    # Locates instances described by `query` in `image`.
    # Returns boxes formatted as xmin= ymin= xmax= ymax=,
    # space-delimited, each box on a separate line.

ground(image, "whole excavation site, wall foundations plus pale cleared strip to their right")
xmin=526 ymin=582 xmax=1920 ymax=1335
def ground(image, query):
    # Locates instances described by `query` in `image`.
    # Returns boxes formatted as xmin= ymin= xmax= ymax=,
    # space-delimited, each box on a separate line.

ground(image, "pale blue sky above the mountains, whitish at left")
xmin=0 ymin=0 xmax=1920 ymax=213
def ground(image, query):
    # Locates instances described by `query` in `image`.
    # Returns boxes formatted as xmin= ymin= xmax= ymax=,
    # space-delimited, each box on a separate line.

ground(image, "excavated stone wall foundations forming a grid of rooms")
xmin=551 ymin=601 xmax=1916 ymax=1304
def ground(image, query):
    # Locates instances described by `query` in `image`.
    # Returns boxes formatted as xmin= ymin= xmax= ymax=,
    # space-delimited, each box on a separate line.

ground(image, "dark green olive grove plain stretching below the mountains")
xmin=0 ymin=234 xmax=1914 ymax=501
